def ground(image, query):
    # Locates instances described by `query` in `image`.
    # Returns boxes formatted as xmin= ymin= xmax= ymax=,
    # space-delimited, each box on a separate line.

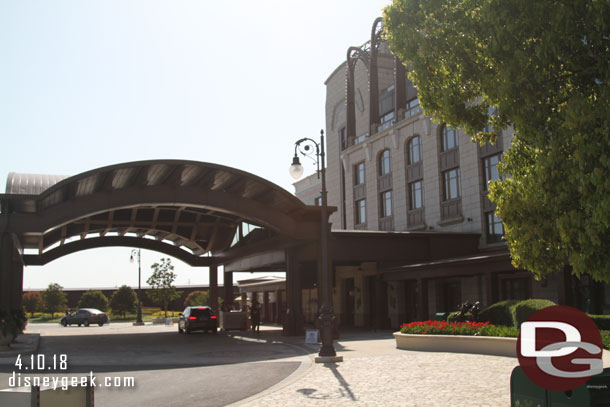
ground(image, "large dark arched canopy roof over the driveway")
xmin=0 ymin=160 xmax=320 ymax=266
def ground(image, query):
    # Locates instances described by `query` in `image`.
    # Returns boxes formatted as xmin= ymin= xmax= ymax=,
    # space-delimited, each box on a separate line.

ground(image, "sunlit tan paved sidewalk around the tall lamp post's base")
xmin=232 ymin=330 xmax=518 ymax=407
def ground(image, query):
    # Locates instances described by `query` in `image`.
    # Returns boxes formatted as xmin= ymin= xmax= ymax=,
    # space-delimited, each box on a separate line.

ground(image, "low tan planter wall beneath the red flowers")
xmin=394 ymin=332 xmax=517 ymax=358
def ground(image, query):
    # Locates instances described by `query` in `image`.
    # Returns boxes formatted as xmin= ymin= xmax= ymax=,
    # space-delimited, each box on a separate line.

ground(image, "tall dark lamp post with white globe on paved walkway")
xmin=290 ymin=130 xmax=343 ymax=363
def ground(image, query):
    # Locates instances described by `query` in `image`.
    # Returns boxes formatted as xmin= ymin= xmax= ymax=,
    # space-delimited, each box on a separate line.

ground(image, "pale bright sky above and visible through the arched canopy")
xmin=0 ymin=0 xmax=390 ymax=290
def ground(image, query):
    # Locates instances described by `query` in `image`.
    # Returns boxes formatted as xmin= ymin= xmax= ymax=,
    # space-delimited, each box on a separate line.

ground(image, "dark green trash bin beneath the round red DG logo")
xmin=510 ymin=366 xmax=610 ymax=407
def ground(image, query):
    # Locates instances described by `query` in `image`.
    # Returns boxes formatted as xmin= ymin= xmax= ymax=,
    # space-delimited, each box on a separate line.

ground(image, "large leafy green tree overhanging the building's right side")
xmin=384 ymin=0 xmax=610 ymax=281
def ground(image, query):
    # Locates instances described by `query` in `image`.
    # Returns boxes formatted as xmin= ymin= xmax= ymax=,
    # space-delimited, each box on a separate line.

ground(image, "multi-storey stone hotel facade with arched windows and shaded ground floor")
xmin=295 ymin=19 xmax=610 ymax=328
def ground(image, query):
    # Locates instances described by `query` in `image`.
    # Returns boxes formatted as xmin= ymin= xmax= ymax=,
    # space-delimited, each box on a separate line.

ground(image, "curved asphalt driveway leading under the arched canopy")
xmin=0 ymin=323 xmax=307 ymax=407
